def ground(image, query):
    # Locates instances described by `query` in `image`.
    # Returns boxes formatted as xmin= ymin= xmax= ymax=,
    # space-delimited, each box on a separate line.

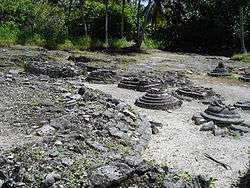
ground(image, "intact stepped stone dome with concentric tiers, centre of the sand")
xmin=135 ymin=88 xmax=182 ymax=110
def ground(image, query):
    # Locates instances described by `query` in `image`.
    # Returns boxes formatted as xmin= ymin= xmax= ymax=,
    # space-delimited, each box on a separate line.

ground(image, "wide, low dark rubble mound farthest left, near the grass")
xmin=25 ymin=61 xmax=86 ymax=78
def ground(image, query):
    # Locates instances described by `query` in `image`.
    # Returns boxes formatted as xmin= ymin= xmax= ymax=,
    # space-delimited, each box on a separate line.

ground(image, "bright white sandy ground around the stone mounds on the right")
xmin=86 ymin=80 xmax=250 ymax=188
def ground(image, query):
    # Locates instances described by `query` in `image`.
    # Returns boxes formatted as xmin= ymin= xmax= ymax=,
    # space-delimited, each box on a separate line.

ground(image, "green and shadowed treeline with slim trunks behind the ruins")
xmin=0 ymin=0 xmax=250 ymax=55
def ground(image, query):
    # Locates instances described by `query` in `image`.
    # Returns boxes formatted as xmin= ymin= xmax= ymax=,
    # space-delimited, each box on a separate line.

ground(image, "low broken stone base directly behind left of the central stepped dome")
xmin=118 ymin=77 xmax=162 ymax=92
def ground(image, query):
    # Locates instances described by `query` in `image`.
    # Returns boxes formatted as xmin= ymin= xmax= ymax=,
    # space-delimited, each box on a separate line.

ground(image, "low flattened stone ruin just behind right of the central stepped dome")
xmin=176 ymin=86 xmax=216 ymax=99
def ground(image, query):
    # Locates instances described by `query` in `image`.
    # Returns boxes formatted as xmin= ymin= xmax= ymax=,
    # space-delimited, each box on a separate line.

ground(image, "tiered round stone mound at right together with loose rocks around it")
xmin=192 ymin=100 xmax=249 ymax=136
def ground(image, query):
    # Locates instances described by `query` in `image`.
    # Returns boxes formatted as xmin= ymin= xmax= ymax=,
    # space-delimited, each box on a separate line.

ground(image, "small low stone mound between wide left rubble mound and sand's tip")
xmin=86 ymin=69 xmax=119 ymax=84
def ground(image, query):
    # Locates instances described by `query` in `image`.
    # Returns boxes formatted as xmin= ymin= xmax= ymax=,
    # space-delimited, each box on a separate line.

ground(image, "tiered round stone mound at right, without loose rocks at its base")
xmin=201 ymin=100 xmax=244 ymax=126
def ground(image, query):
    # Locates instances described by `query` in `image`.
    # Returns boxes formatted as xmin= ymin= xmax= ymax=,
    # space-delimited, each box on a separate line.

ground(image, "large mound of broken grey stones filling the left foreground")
xmin=0 ymin=81 xmax=211 ymax=188
